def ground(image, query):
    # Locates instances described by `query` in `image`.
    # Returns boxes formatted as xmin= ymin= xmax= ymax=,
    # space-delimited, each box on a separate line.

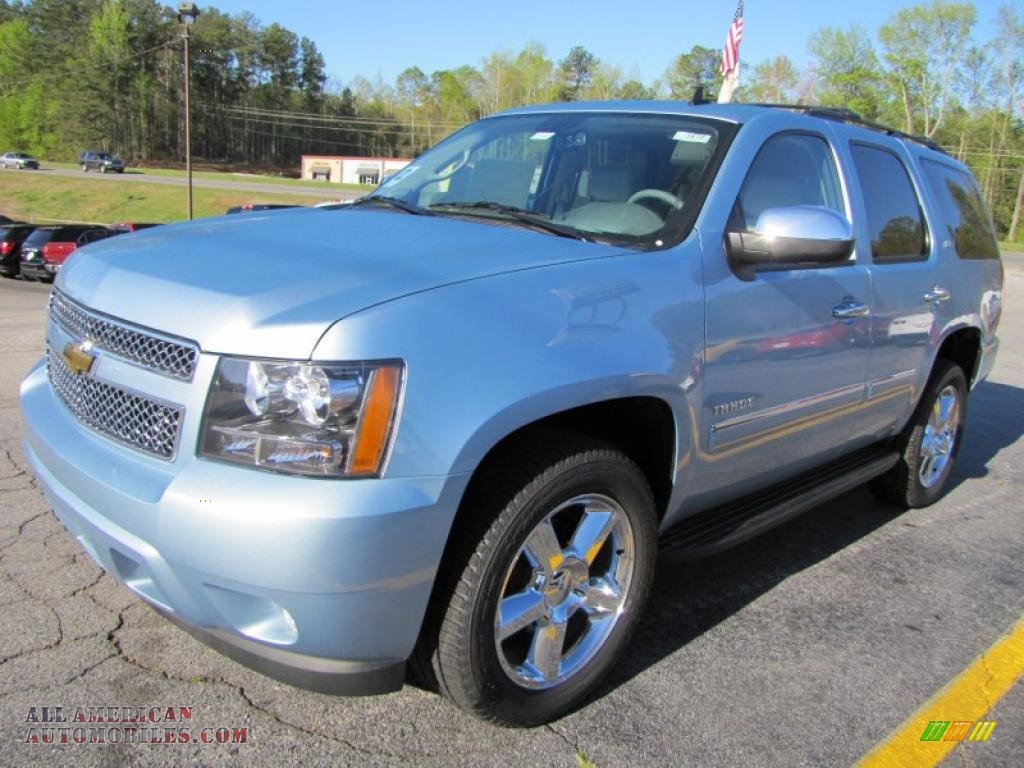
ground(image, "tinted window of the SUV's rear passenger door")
xmin=851 ymin=144 xmax=928 ymax=263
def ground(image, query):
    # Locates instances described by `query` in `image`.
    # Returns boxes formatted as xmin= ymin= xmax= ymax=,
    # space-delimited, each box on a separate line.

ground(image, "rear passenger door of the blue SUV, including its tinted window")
xmin=849 ymin=137 xmax=937 ymax=440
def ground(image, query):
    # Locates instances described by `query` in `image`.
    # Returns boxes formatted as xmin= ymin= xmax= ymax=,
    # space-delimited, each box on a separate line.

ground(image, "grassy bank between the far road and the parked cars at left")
xmin=0 ymin=172 xmax=323 ymax=223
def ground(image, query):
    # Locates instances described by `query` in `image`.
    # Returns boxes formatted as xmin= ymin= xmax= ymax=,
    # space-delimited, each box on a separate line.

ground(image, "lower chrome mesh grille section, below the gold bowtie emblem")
xmin=46 ymin=346 xmax=184 ymax=460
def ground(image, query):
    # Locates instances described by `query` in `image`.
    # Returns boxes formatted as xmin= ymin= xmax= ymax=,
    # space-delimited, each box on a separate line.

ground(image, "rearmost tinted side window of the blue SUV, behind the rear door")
xmin=922 ymin=160 xmax=999 ymax=259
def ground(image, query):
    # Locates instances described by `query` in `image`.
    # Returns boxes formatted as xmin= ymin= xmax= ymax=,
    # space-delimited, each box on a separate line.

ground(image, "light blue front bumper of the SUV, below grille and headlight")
xmin=22 ymin=362 xmax=468 ymax=695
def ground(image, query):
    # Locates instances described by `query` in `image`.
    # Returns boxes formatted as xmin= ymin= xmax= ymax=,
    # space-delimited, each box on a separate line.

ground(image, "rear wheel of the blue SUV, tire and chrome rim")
xmin=870 ymin=358 xmax=968 ymax=509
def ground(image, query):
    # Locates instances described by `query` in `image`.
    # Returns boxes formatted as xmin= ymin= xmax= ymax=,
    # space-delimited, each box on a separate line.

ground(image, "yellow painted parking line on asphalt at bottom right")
xmin=857 ymin=616 xmax=1024 ymax=768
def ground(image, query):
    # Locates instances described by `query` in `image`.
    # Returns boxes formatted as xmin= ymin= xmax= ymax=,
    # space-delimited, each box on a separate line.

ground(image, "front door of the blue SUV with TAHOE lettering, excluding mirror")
xmin=696 ymin=123 xmax=870 ymax=494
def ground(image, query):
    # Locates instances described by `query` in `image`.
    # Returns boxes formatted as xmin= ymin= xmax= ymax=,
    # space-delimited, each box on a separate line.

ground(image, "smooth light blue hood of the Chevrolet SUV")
xmin=57 ymin=208 xmax=622 ymax=358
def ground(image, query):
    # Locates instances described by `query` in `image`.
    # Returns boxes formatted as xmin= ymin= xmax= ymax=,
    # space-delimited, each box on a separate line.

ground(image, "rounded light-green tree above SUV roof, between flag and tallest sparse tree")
xmin=808 ymin=25 xmax=883 ymax=119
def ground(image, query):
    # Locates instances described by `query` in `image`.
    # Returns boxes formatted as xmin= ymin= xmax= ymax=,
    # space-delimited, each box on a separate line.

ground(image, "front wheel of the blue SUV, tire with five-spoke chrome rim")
xmin=428 ymin=433 xmax=657 ymax=726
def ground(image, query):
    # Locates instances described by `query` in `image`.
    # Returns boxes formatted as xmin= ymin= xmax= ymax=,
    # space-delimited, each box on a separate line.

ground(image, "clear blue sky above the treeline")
xmin=207 ymin=0 xmax=1007 ymax=83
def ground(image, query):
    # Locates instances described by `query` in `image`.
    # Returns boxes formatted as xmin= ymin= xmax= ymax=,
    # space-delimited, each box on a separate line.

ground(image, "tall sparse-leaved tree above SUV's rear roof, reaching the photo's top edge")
xmin=879 ymin=0 xmax=977 ymax=138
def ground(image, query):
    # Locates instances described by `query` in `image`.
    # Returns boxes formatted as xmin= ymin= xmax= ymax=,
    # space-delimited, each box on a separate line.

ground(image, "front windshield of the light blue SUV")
xmin=370 ymin=112 xmax=734 ymax=247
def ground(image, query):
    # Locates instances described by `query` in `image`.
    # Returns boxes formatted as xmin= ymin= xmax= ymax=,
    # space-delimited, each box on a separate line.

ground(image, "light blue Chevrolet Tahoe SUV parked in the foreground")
xmin=22 ymin=102 xmax=1002 ymax=725
